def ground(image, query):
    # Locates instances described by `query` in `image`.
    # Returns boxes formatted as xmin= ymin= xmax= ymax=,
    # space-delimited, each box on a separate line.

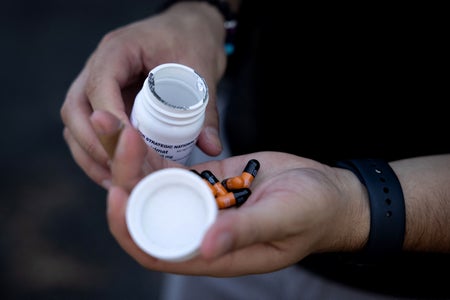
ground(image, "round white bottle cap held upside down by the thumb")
xmin=126 ymin=168 xmax=218 ymax=261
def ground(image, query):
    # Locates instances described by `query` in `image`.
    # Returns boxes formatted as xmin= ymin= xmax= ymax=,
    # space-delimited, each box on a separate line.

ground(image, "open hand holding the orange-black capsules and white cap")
xmin=108 ymin=113 xmax=370 ymax=276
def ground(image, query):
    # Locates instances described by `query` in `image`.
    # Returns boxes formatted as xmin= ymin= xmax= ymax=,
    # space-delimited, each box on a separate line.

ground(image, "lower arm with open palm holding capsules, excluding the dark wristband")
xmin=104 ymin=116 xmax=450 ymax=276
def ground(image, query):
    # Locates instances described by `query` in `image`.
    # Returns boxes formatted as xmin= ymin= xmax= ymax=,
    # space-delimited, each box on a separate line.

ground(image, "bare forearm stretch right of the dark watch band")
xmin=390 ymin=154 xmax=450 ymax=252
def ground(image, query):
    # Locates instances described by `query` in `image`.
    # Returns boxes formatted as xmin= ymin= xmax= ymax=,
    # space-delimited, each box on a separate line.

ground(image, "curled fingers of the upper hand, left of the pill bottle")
xmin=60 ymin=35 xmax=141 ymax=187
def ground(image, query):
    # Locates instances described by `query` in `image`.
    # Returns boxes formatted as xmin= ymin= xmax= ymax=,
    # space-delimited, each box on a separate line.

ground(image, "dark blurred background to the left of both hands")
xmin=0 ymin=0 xmax=167 ymax=299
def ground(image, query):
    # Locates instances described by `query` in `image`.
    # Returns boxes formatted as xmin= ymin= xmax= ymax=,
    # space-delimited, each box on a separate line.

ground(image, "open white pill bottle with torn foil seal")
xmin=130 ymin=63 xmax=209 ymax=165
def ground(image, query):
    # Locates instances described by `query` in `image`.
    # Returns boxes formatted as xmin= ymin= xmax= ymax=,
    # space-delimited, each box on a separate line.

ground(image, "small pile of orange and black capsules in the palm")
xmin=191 ymin=159 xmax=260 ymax=209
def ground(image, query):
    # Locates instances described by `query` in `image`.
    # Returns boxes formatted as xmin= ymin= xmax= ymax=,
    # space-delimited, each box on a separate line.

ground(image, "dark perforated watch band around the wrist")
xmin=336 ymin=158 xmax=406 ymax=258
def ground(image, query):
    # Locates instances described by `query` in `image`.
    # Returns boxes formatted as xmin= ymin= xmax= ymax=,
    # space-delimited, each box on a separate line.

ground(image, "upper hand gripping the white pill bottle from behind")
xmin=61 ymin=2 xmax=226 ymax=188
